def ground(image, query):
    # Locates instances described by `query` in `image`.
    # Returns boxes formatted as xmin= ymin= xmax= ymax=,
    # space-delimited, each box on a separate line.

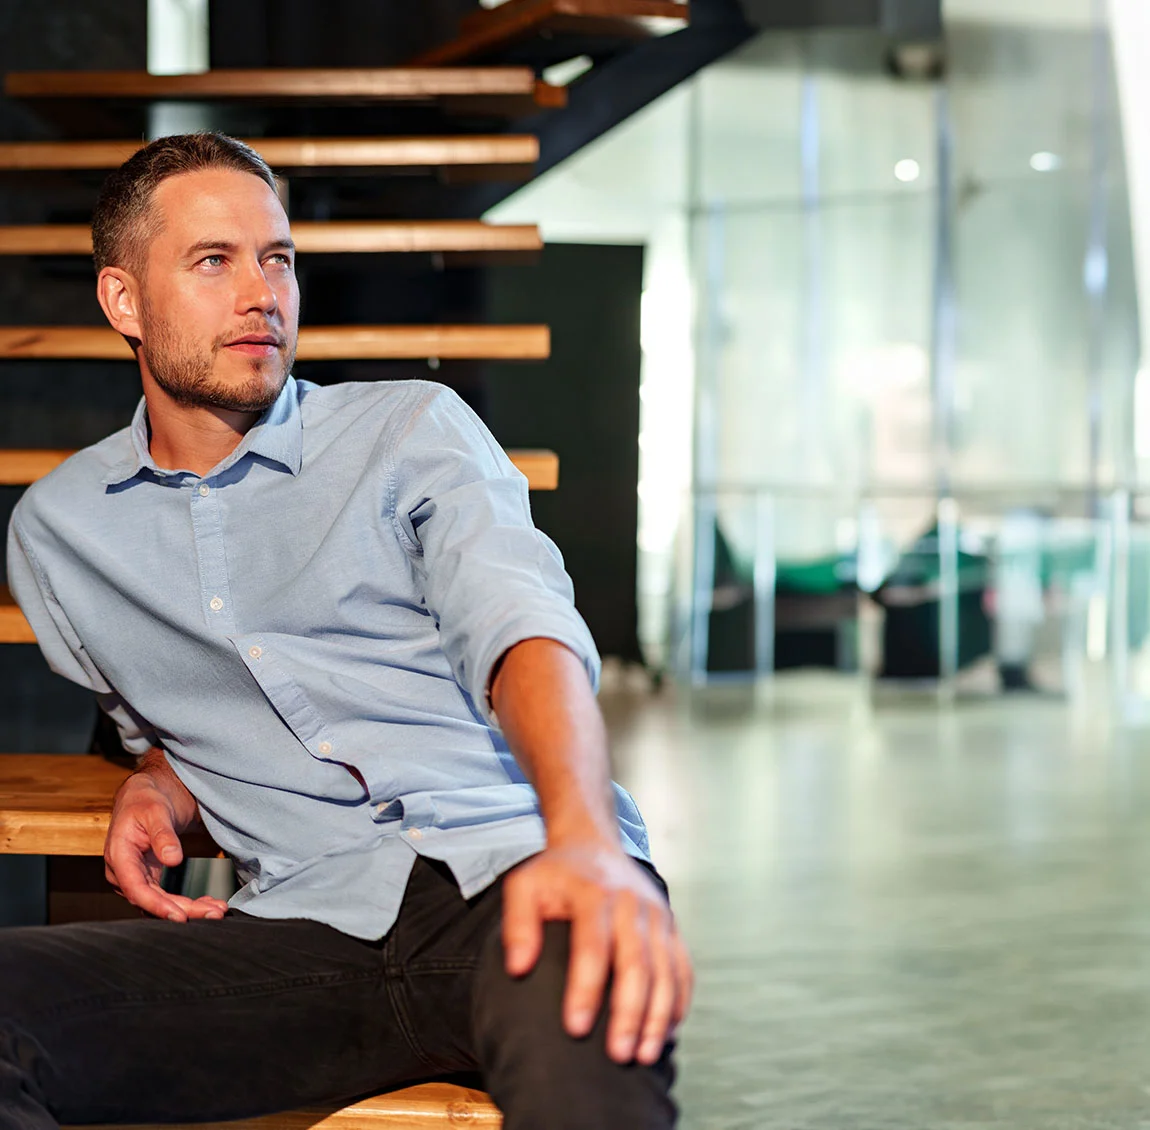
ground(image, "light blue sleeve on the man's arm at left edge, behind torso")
xmin=7 ymin=507 xmax=156 ymax=754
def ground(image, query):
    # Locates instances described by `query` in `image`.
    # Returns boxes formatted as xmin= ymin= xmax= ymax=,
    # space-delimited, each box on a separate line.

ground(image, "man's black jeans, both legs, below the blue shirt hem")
xmin=0 ymin=859 xmax=675 ymax=1130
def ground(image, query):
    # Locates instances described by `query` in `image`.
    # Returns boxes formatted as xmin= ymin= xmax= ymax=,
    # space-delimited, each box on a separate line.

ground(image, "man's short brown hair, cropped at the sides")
xmin=92 ymin=132 xmax=276 ymax=275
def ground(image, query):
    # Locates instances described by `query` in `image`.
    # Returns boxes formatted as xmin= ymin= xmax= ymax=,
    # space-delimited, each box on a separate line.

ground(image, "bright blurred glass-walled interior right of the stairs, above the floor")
xmin=495 ymin=0 xmax=1150 ymax=718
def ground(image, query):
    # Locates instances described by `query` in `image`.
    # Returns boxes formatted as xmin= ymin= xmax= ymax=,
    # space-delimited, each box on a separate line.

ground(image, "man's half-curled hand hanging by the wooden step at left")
xmin=104 ymin=754 xmax=228 ymax=922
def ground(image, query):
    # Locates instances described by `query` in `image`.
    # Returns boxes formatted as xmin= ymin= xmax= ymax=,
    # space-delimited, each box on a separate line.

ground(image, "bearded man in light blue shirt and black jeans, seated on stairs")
xmin=0 ymin=134 xmax=691 ymax=1130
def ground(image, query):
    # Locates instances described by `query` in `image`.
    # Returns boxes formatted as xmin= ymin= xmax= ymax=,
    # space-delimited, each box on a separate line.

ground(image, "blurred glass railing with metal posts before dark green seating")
xmin=669 ymin=485 xmax=1150 ymax=717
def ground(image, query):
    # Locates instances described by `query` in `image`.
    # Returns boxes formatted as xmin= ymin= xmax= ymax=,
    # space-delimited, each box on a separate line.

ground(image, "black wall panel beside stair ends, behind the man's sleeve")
xmin=483 ymin=244 xmax=643 ymax=660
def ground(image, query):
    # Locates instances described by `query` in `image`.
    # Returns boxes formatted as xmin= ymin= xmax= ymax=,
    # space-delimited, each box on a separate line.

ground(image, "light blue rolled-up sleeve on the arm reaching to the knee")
xmin=391 ymin=386 xmax=599 ymax=725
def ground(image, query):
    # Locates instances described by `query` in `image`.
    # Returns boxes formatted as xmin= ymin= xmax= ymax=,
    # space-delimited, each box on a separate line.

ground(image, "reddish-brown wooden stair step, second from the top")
xmin=5 ymin=67 xmax=567 ymax=114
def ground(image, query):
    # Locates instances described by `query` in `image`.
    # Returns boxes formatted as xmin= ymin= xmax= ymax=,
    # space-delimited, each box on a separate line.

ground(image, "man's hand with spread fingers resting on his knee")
xmin=503 ymin=845 xmax=692 ymax=1063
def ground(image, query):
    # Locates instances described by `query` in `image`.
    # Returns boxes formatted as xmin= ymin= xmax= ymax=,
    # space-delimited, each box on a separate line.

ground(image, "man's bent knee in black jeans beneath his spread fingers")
xmin=474 ymin=922 xmax=675 ymax=1130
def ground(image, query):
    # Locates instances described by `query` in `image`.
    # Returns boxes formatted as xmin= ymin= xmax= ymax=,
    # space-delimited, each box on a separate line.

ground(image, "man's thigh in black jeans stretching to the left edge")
xmin=0 ymin=914 xmax=429 ymax=1122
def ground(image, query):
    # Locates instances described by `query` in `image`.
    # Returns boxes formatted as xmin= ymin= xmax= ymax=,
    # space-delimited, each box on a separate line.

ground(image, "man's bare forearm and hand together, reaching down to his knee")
xmin=491 ymin=638 xmax=692 ymax=1063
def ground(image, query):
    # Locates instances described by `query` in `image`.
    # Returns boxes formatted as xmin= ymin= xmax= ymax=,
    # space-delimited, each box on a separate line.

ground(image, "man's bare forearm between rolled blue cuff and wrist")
xmin=491 ymin=638 xmax=619 ymax=847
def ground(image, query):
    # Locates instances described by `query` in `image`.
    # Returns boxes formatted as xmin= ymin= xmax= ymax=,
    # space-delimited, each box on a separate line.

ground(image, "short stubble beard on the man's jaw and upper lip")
xmin=140 ymin=301 xmax=296 ymax=413
